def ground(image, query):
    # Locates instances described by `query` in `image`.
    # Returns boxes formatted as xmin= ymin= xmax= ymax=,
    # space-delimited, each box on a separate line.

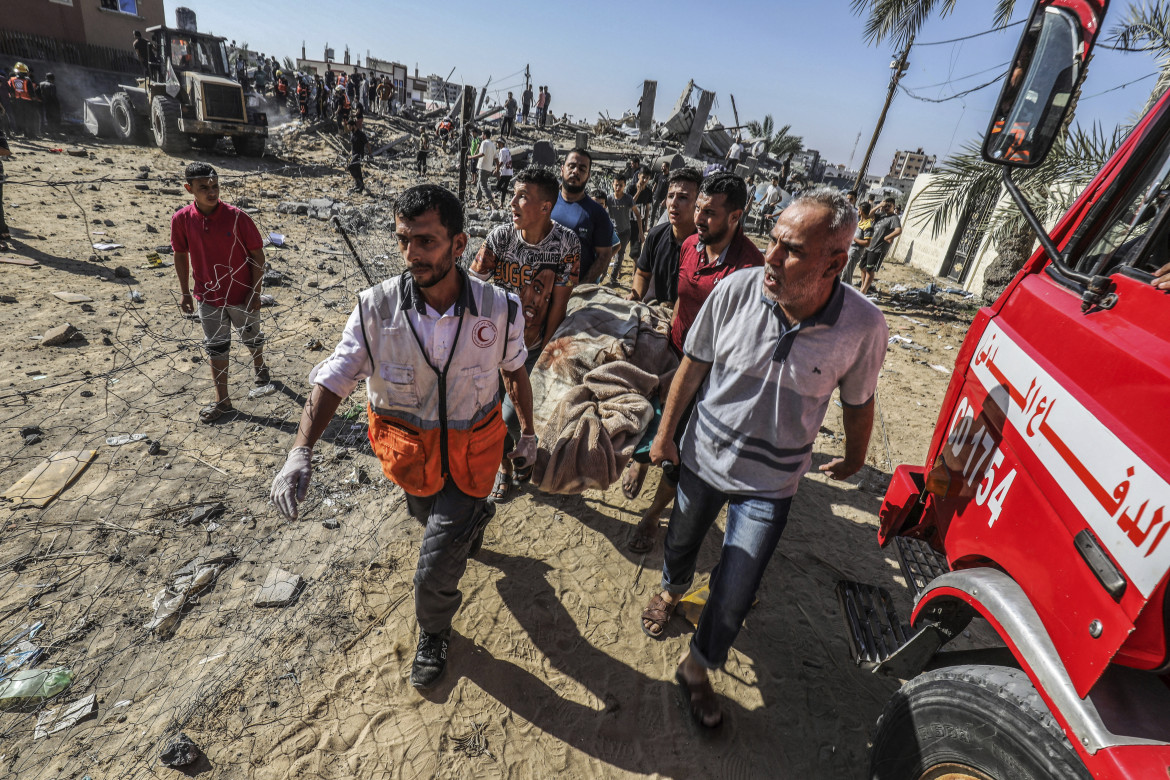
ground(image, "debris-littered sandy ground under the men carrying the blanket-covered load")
xmin=0 ymin=122 xmax=972 ymax=780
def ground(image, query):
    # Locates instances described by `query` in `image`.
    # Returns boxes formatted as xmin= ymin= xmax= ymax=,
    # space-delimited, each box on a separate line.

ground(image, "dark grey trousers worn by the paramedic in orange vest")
xmin=406 ymin=479 xmax=495 ymax=634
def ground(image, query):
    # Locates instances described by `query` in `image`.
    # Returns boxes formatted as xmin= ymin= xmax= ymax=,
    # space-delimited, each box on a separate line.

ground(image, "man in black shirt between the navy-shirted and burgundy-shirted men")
xmin=626 ymin=168 xmax=703 ymax=303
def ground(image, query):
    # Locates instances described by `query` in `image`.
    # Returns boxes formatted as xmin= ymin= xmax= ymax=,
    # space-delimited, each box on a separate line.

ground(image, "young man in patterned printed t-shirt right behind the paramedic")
xmin=470 ymin=166 xmax=581 ymax=502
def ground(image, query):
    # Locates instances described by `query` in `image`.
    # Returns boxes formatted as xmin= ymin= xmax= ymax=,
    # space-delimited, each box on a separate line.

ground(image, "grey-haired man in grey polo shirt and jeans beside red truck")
xmin=639 ymin=187 xmax=888 ymax=729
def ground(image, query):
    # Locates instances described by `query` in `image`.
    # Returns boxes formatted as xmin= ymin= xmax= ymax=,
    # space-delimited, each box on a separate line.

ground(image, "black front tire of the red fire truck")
xmin=869 ymin=665 xmax=1092 ymax=780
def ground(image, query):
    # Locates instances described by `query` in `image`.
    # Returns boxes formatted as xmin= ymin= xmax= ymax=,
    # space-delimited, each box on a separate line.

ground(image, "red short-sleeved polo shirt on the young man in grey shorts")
xmin=171 ymin=201 xmax=263 ymax=306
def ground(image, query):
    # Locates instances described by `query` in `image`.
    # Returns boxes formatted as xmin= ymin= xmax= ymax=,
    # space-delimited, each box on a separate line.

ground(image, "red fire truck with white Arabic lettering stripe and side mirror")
xmin=838 ymin=0 xmax=1170 ymax=780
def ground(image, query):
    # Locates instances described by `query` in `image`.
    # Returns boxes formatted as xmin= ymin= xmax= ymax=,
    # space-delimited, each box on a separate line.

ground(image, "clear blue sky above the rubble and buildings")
xmin=182 ymin=0 xmax=1157 ymax=173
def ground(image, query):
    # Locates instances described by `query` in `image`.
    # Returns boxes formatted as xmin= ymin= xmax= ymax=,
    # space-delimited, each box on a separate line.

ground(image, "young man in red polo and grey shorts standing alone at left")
xmin=171 ymin=163 xmax=271 ymax=422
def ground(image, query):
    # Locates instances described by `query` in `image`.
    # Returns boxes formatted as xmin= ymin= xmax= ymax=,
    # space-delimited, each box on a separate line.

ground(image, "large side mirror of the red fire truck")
xmin=983 ymin=0 xmax=1100 ymax=168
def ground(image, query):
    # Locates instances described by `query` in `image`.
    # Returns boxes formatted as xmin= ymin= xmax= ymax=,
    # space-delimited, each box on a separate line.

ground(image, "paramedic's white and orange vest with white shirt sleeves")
xmin=309 ymin=267 xmax=528 ymax=498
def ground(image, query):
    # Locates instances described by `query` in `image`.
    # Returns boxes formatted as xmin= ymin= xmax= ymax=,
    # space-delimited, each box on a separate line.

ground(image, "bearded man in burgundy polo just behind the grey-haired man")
xmin=629 ymin=173 xmax=764 ymax=553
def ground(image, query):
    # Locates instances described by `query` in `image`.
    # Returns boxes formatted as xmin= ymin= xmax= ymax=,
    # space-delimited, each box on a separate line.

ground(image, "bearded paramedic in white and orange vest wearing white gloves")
xmin=271 ymin=185 xmax=536 ymax=688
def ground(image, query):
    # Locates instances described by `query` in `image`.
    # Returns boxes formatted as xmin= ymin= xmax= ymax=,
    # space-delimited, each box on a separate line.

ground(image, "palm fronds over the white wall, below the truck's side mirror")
xmin=907 ymin=125 xmax=1128 ymax=303
